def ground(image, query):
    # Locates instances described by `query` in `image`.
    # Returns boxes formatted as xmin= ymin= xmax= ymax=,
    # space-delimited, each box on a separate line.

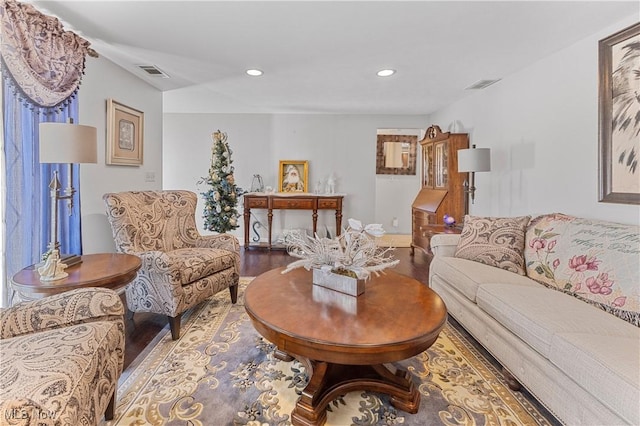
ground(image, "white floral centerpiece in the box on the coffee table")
xmin=282 ymin=219 xmax=400 ymax=280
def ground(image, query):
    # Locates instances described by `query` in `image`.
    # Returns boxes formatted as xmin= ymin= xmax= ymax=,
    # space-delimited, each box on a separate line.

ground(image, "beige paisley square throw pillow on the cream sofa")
xmin=455 ymin=215 xmax=531 ymax=275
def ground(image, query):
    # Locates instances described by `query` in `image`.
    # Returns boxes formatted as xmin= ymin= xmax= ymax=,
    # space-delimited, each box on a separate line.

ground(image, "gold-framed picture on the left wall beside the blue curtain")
xmin=106 ymin=99 xmax=144 ymax=166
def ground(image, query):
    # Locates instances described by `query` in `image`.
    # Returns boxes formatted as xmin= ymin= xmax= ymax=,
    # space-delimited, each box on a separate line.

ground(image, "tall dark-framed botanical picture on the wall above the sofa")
xmin=598 ymin=23 xmax=640 ymax=204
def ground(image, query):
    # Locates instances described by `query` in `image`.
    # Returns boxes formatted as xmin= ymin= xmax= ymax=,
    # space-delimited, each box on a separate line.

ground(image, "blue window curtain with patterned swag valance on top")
xmin=0 ymin=1 xmax=90 ymax=306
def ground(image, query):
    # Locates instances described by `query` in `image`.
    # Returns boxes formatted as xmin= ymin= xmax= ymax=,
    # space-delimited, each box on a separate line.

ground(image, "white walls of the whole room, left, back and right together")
xmin=80 ymin=17 xmax=640 ymax=253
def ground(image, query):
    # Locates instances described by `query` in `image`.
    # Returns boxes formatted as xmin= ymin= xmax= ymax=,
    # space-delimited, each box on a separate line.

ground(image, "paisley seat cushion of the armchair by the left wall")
xmin=167 ymin=248 xmax=235 ymax=285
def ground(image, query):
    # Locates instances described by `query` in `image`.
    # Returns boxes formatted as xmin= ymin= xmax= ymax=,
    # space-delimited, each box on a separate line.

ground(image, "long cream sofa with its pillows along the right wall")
xmin=429 ymin=214 xmax=640 ymax=425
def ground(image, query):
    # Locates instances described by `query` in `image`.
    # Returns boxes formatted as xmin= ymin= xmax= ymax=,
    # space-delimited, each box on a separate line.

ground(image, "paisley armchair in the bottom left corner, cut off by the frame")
xmin=0 ymin=288 xmax=125 ymax=426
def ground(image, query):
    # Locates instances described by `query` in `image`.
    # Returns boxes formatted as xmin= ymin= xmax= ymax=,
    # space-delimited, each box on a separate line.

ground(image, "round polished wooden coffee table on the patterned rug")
xmin=244 ymin=268 xmax=447 ymax=425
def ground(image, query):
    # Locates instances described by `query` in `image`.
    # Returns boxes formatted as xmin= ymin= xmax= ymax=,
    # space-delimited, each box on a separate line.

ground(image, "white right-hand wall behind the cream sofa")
xmin=431 ymin=16 xmax=640 ymax=224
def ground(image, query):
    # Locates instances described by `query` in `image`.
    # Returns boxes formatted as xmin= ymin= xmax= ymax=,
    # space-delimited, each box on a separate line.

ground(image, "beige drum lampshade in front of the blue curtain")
xmin=40 ymin=123 xmax=98 ymax=163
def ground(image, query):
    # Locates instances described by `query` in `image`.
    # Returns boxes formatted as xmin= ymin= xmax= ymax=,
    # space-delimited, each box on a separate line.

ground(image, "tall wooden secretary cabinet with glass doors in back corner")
xmin=411 ymin=125 xmax=469 ymax=254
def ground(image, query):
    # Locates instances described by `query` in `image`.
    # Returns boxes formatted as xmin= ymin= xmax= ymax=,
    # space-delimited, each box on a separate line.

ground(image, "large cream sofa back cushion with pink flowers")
xmin=525 ymin=213 xmax=640 ymax=326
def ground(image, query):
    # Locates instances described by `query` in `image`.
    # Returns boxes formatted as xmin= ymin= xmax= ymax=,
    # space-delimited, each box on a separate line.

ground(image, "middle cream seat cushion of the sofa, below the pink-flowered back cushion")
xmin=476 ymin=284 xmax=636 ymax=358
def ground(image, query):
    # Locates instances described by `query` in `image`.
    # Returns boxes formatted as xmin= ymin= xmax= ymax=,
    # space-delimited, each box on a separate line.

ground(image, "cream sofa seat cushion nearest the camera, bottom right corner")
xmin=549 ymin=328 xmax=640 ymax=425
